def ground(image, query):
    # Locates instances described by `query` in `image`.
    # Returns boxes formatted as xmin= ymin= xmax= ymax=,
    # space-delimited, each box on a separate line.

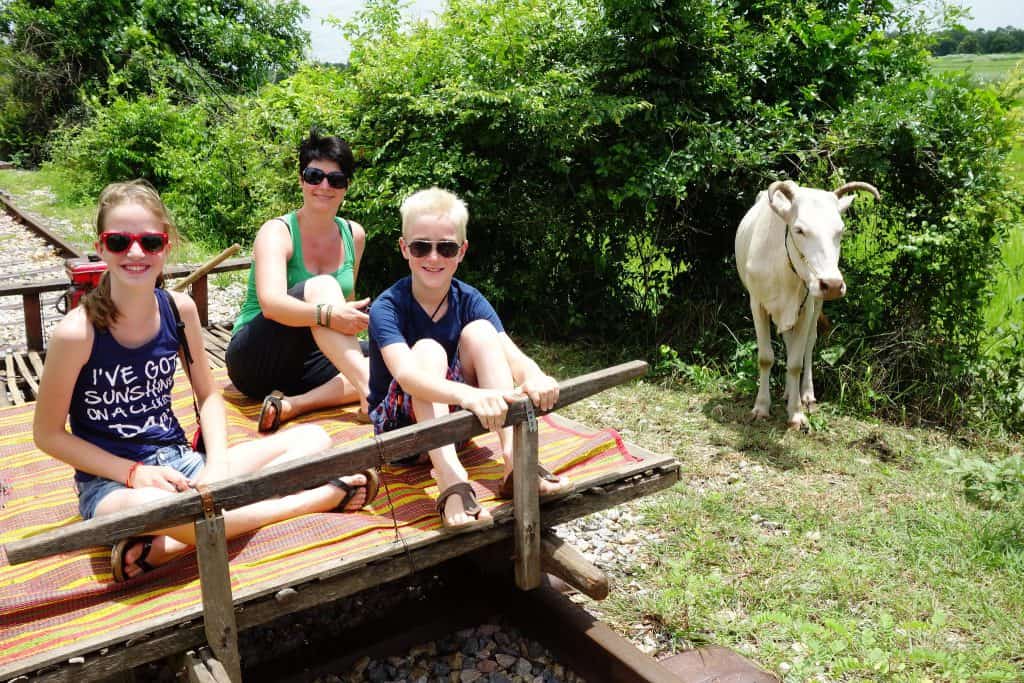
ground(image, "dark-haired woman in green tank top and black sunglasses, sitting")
xmin=225 ymin=129 xmax=370 ymax=432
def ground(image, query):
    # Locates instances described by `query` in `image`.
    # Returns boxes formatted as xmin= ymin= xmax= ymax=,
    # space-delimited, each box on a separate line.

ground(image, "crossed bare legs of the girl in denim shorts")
xmin=103 ymin=425 xmax=367 ymax=577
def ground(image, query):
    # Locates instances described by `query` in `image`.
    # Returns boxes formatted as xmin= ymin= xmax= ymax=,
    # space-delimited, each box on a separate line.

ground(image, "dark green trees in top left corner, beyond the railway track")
xmin=0 ymin=0 xmax=308 ymax=162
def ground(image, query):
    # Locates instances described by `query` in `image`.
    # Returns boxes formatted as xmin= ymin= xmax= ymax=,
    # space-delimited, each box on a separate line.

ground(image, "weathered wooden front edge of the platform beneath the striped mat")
xmin=6 ymin=458 xmax=680 ymax=683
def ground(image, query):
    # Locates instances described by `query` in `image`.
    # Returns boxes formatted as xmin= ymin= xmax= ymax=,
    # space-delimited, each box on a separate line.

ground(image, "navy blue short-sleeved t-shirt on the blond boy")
xmin=369 ymin=276 xmax=505 ymax=410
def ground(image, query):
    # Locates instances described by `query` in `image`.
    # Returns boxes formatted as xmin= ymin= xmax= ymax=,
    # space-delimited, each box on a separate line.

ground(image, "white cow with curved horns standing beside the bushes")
xmin=736 ymin=180 xmax=881 ymax=429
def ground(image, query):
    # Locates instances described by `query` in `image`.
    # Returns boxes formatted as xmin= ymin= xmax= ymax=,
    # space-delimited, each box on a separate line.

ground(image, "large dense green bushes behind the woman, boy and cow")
xmin=28 ymin=0 xmax=1024 ymax=432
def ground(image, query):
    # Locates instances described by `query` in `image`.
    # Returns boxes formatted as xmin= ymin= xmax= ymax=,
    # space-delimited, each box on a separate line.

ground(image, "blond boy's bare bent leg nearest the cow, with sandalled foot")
xmin=459 ymin=321 xmax=571 ymax=496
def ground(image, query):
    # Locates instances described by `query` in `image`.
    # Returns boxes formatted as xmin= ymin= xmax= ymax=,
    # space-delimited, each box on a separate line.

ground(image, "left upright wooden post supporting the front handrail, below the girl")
xmin=196 ymin=499 xmax=242 ymax=683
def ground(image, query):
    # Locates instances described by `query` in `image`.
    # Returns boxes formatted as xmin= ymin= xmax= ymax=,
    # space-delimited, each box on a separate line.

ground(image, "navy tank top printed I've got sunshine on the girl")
xmin=69 ymin=290 xmax=187 ymax=483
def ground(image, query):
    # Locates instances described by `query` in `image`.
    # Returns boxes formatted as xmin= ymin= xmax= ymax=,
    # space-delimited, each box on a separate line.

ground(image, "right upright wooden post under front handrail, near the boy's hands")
xmin=512 ymin=398 xmax=541 ymax=591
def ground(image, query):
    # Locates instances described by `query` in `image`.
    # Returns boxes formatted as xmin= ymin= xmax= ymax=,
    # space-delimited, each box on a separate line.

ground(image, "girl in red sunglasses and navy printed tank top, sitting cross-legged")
xmin=33 ymin=181 xmax=378 ymax=581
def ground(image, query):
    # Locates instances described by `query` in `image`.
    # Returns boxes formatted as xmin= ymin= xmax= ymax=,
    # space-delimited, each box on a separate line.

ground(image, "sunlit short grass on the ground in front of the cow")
xmin=551 ymin=370 xmax=1024 ymax=681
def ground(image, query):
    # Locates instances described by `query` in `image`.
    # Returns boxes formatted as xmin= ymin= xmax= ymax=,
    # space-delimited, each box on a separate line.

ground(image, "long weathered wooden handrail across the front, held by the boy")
xmin=6 ymin=360 xmax=647 ymax=564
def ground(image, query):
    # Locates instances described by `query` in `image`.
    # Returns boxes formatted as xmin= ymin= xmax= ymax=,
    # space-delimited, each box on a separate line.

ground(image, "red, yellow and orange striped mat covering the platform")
xmin=0 ymin=369 xmax=639 ymax=668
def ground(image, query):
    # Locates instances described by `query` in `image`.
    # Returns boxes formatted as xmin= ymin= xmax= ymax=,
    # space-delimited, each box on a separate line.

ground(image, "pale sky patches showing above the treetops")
xmin=304 ymin=0 xmax=1024 ymax=61
